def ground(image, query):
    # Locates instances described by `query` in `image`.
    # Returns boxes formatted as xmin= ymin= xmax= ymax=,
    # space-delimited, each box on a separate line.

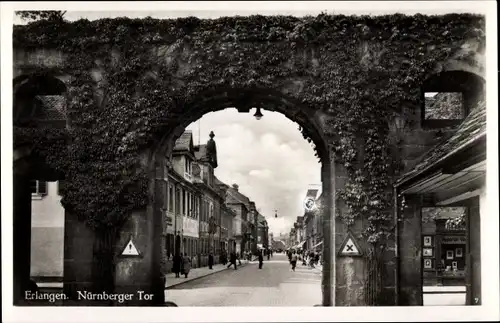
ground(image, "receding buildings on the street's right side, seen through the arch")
xmin=286 ymin=189 xmax=323 ymax=252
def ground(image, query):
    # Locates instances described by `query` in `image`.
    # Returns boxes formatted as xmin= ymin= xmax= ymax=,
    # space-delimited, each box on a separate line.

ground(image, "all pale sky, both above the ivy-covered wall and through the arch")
xmin=4 ymin=1 xmax=485 ymax=235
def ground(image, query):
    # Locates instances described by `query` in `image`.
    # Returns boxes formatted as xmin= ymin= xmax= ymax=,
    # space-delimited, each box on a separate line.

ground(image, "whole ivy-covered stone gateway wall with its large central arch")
xmin=13 ymin=14 xmax=485 ymax=306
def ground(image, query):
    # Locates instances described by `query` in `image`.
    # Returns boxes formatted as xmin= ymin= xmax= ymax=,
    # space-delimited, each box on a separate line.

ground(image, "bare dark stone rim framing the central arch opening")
xmin=106 ymin=88 xmax=336 ymax=306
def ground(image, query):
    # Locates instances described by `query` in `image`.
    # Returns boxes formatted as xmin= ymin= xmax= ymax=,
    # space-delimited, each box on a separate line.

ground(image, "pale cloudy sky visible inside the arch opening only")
xmin=187 ymin=109 xmax=321 ymax=235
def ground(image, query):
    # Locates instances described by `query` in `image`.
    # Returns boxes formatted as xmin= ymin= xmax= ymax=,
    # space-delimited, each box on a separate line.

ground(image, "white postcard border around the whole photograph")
xmin=0 ymin=1 xmax=500 ymax=322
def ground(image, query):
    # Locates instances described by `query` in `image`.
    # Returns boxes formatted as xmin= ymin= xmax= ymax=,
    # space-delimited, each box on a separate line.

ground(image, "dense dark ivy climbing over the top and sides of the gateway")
xmin=13 ymin=14 xmax=485 ymax=302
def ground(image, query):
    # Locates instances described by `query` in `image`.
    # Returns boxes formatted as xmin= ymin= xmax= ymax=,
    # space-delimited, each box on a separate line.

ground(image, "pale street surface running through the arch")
xmin=165 ymin=254 xmax=321 ymax=307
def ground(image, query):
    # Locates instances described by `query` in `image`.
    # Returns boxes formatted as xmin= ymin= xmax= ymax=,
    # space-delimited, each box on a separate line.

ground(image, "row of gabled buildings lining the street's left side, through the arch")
xmin=165 ymin=131 xmax=270 ymax=267
